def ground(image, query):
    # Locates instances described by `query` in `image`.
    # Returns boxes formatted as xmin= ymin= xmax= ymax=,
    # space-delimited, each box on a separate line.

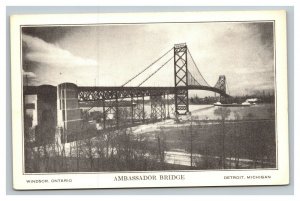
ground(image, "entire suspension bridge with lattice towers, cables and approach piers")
xmin=24 ymin=43 xmax=229 ymax=142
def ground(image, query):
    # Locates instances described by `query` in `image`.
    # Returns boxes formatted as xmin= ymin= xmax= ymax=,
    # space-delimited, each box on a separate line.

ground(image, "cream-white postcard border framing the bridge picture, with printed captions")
xmin=11 ymin=11 xmax=289 ymax=189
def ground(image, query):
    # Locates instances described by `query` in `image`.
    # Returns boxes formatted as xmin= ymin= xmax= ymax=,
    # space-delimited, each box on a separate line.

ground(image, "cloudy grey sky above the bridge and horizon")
xmin=22 ymin=22 xmax=274 ymax=95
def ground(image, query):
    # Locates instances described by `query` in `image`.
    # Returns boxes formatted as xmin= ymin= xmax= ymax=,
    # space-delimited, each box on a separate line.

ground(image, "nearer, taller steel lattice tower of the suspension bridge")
xmin=174 ymin=43 xmax=189 ymax=115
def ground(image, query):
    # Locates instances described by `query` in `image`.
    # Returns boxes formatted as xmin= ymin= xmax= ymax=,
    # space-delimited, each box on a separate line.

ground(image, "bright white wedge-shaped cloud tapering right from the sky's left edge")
xmin=22 ymin=34 xmax=97 ymax=68
